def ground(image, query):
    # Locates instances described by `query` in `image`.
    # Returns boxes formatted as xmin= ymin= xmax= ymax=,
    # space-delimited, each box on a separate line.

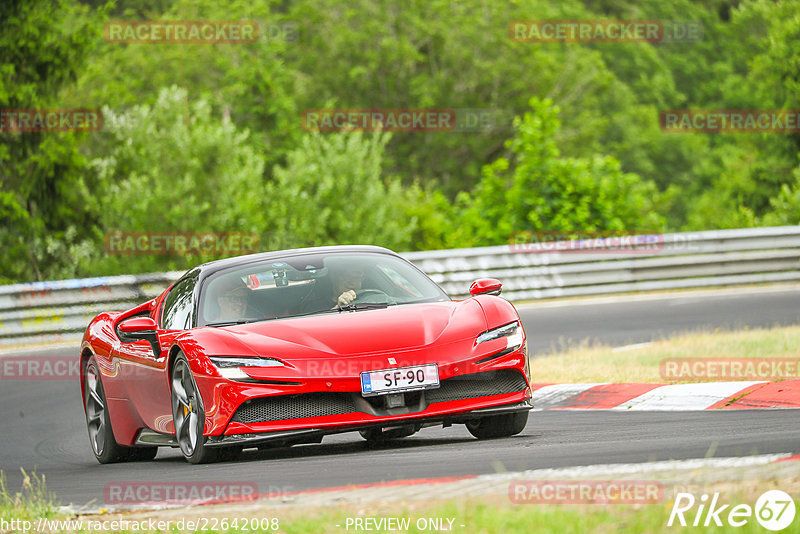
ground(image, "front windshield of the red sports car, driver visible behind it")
xmin=197 ymin=252 xmax=450 ymax=326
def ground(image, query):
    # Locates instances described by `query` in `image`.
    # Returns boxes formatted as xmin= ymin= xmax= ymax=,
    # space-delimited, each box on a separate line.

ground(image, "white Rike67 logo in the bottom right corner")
xmin=667 ymin=490 xmax=796 ymax=532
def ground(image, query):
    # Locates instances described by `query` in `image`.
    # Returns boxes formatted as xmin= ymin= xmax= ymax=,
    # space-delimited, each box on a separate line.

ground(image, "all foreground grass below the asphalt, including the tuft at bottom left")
xmin=0 ymin=471 xmax=800 ymax=534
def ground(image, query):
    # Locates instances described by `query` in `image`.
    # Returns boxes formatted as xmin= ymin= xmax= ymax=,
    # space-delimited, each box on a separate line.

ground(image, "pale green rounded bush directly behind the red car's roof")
xmin=266 ymin=132 xmax=417 ymax=250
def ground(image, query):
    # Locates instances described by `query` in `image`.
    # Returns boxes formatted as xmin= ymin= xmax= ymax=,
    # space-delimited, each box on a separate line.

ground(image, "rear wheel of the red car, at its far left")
xmin=83 ymin=356 xmax=130 ymax=464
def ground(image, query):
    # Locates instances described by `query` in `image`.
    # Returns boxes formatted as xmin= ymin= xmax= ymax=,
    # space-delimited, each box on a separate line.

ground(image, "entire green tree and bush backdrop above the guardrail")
xmin=0 ymin=0 xmax=800 ymax=283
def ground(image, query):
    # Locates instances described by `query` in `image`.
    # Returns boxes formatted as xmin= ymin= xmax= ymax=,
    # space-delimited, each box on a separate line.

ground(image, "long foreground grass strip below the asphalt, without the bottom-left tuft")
xmin=76 ymin=476 xmax=800 ymax=534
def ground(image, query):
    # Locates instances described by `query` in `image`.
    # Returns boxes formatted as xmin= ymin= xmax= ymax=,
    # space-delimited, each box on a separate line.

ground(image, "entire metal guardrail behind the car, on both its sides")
xmin=0 ymin=226 xmax=800 ymax=346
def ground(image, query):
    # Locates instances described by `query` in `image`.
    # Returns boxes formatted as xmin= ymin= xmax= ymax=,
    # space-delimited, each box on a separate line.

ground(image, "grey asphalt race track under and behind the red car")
xmin=0 ymin=289 xmax=800 ymax=507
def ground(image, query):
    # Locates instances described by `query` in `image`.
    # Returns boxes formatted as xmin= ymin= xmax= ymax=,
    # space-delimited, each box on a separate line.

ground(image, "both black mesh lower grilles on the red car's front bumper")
xmin=233 ymin=369 xmax=527 ymax=424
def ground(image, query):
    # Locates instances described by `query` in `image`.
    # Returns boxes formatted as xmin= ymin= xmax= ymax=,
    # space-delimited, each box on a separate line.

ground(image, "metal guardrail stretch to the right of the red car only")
xmin=404 ymin=226 xmax=800 ymax=300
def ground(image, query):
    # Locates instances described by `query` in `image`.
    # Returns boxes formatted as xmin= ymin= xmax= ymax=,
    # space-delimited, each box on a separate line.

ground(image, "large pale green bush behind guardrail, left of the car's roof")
xmin=83 ymin=86 xmax=266 ymax=274
